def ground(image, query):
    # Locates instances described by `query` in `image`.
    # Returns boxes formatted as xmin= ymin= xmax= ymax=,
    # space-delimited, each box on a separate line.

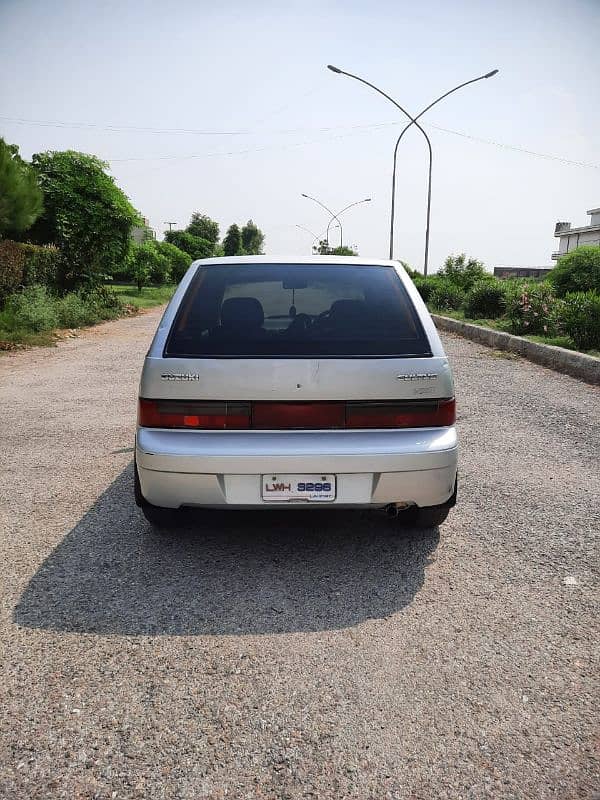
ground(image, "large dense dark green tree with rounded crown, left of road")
xmin=27 ymin=150 xmax=140 ymax=291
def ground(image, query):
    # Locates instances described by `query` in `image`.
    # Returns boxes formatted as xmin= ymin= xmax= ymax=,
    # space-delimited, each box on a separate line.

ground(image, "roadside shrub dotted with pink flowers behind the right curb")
xmin=505 ymin=281 xmax=557 ymax=336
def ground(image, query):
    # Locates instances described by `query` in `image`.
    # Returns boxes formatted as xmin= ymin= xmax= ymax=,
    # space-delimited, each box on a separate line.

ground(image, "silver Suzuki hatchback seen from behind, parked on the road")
xmin=135 ymin=256 xmax=457 ymax=527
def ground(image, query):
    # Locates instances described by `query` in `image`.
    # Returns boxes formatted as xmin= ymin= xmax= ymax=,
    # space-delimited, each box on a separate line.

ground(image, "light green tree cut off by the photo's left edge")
xmin=0 ymin=139 xmax=43 ymax=236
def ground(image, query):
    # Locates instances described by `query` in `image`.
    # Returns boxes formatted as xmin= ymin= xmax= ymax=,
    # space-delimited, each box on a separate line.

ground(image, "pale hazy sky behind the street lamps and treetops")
xmin=0 ymin=0 xmax=600 ymax=268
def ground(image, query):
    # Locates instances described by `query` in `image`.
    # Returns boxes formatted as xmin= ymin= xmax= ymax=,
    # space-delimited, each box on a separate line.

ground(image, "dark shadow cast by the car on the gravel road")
xmin=13 ymin=465 xmax=439 ymax=635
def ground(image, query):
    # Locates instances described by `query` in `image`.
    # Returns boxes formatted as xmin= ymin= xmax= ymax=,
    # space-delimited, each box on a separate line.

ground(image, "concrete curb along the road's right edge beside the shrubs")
xmin=431 ymin=314 xmax=600 ymax=385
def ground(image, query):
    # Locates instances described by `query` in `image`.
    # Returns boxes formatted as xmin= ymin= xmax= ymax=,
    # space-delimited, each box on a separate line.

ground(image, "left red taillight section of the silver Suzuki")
xmin=138 ymin=399 xmax=250 ymax=430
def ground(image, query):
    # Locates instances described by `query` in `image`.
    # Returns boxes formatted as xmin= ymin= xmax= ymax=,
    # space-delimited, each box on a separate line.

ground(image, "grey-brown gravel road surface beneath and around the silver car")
xmin=0 ymin=311 xmax=600 ymax=800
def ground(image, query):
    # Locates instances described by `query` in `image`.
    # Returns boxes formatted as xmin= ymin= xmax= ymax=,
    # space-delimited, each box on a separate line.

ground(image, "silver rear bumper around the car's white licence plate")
xmin=136 ymin=427 xmax=457 ymax=509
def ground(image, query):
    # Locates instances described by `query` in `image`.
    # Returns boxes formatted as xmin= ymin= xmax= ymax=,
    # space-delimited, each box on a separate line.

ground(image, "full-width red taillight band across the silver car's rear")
xmin=138 ymin=399 xmax=456 ymax=430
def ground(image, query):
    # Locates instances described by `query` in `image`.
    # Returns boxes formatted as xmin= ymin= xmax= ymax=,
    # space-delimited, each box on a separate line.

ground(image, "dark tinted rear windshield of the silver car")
xmin=164 ymin=264 xmax=431 ymax=358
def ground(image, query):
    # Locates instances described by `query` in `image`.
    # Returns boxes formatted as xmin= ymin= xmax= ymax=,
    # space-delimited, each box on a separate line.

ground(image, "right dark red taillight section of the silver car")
xmin=346 ymin=398 xmax=456 ymax=428
